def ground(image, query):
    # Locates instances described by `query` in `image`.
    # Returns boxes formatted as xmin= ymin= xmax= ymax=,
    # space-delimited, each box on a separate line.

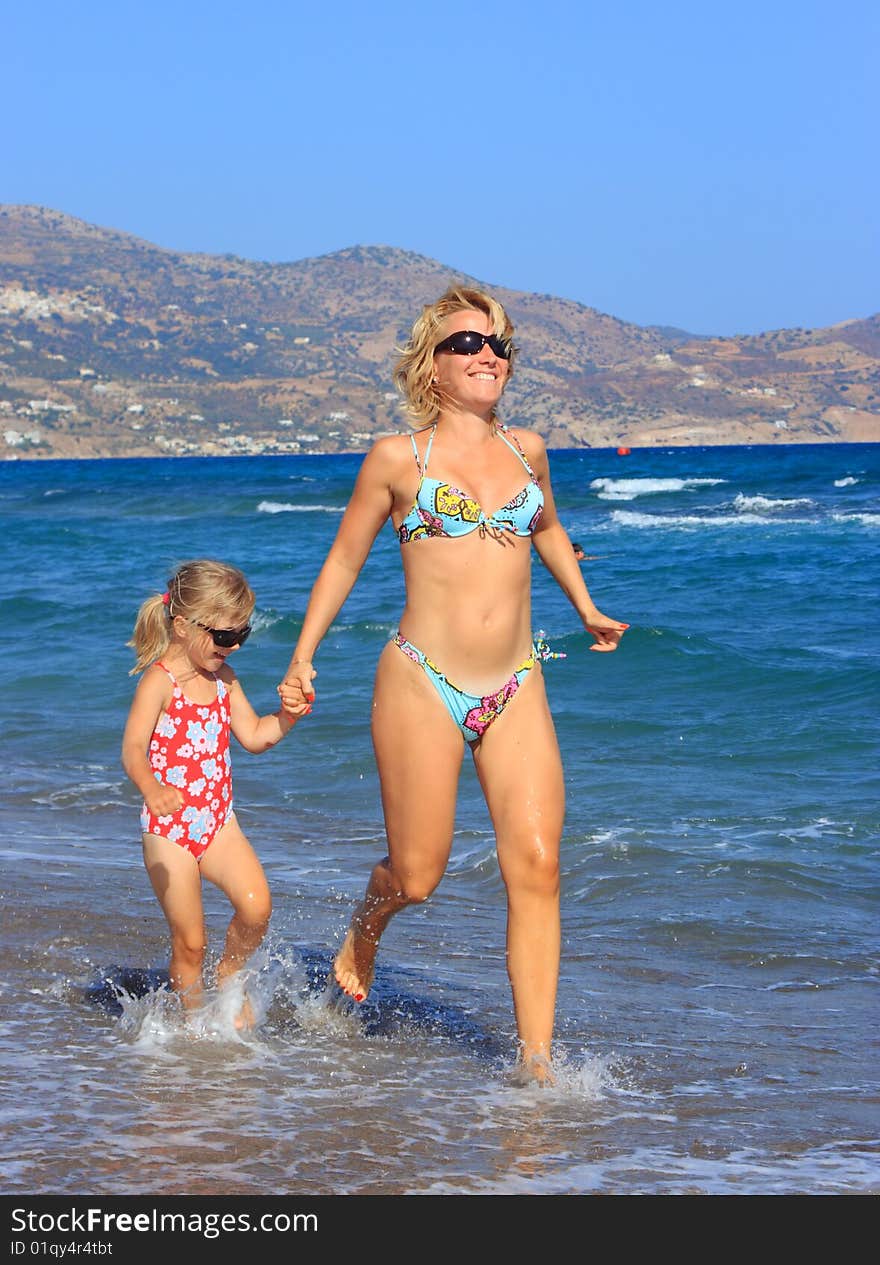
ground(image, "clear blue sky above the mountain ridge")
xmin=0 ymin=0 xmax=880 ymax=334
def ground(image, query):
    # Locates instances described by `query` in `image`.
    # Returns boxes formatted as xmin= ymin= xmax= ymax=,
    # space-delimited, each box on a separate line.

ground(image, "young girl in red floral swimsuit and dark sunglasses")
xmin=123 ymin=559 xmax=305 ymax=1028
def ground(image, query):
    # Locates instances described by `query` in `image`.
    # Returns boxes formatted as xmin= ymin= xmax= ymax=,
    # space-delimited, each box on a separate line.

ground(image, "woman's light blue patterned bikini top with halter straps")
xmin=397 ymin=423 xmax=544 ymax=545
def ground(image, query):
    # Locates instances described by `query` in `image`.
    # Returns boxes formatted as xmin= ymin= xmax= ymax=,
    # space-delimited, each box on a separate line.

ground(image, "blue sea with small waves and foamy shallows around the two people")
xmin=0 ymin=444 xmax=880 ymax=1195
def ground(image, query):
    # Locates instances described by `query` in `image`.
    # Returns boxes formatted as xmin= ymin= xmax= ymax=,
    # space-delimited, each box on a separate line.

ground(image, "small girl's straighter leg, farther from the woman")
xmin=143 ymin=835 xmax=206 ymax=1009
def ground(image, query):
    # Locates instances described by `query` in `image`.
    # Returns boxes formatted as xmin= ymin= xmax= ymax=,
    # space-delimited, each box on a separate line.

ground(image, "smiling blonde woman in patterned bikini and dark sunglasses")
xmin=278 ymin=287 xmax=628 ymax=1082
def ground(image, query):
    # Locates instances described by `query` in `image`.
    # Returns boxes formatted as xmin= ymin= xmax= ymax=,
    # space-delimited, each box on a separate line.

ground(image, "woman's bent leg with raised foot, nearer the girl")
xmin=334 ymin=643 xmax=464 ymax=1001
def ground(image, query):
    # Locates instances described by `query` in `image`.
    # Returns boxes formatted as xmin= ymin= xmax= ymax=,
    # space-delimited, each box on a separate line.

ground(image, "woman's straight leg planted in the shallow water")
xmin=473 ymin=667 xmax=565 ymax=1080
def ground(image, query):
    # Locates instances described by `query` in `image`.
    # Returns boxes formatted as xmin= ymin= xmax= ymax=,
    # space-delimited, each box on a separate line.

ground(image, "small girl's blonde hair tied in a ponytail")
xmin=126 ymin=558 xmax=257 ymax=677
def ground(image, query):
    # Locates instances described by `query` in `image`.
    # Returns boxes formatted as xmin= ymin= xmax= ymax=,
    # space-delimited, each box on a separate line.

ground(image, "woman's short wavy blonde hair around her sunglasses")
xmin=394 ymin=286 xmax=516 ymax=426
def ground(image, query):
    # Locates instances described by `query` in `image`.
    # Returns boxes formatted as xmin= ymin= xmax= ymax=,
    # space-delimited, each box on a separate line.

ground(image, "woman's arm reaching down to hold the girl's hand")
xmin=278 ymin=436 xmax=398 ymax=711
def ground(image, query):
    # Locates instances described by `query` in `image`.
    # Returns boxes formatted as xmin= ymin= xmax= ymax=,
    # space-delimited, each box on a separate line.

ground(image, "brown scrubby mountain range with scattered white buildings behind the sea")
xmin=0 ymin=205 xmax=880 ymax=458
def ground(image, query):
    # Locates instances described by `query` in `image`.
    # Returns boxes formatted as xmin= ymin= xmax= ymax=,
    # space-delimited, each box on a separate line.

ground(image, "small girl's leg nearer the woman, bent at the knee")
xmin=201 ymin=815 xmax=272 ymax=985
